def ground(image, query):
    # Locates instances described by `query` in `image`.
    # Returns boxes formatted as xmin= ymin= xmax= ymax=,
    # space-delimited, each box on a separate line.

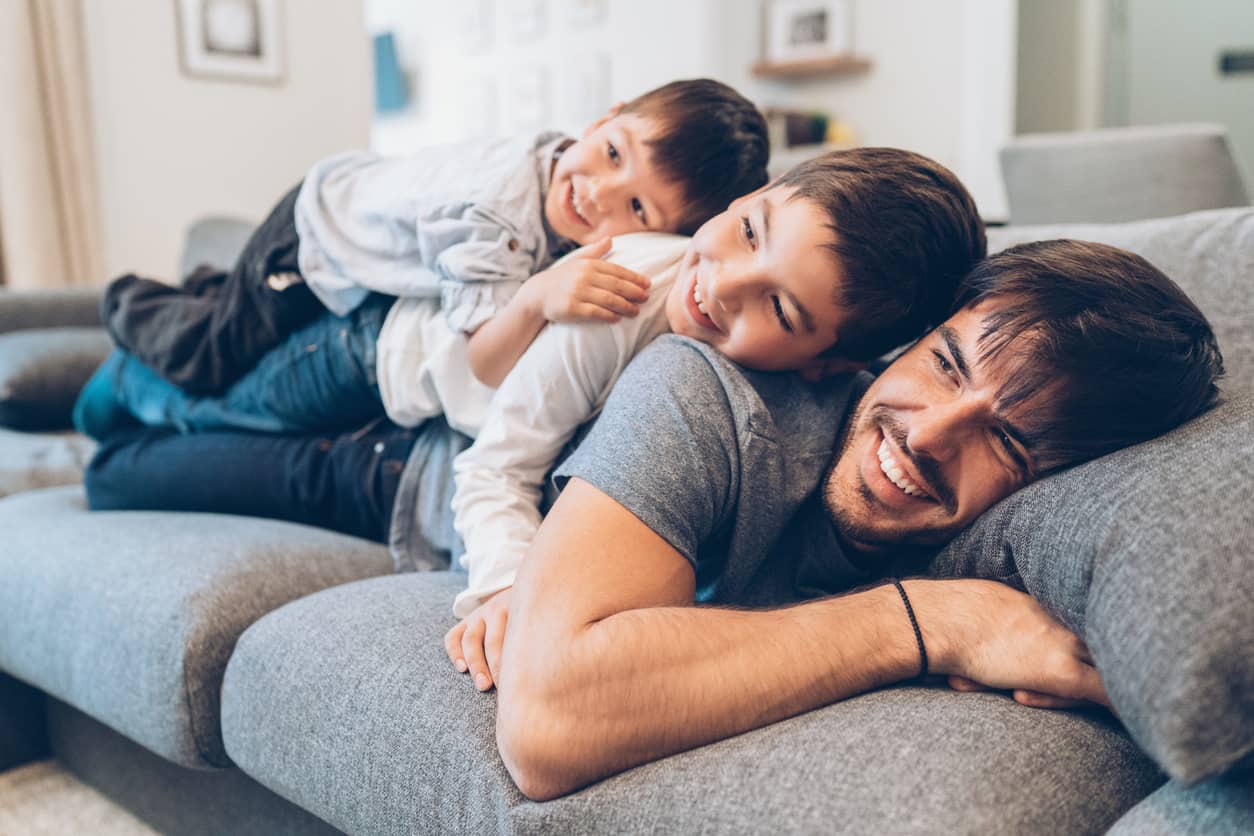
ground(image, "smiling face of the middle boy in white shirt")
xmin=666 ymin=187 xmax=846 ymax=371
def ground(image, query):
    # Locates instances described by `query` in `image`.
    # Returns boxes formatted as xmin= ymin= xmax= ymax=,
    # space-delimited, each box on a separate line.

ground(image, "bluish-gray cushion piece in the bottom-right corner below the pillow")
xmin=1109 ymin=772 xmax=1254 ymax=836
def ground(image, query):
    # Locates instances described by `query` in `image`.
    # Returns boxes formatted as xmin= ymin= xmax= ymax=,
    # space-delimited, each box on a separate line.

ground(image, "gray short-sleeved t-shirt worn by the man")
xmin=554 ymin=335 xmax=869 ymax=605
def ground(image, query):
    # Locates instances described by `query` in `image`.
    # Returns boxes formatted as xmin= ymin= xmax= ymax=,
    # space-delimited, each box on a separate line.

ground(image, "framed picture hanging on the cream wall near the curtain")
xmin=174 ymin=0 xmax=283 ymax=84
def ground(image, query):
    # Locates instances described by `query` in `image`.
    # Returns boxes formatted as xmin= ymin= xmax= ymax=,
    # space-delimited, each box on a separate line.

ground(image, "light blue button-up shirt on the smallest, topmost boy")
xmin=296 ymin=133 xmax=573 ymax=333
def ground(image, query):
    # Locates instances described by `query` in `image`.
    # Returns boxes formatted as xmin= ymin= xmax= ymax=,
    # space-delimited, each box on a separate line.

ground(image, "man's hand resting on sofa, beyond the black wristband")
xmin=904 ymin=579 xmax=1110 ymax=708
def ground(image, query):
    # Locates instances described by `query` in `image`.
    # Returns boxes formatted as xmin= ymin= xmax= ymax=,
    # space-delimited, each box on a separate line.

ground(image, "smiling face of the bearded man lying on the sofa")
xmin=824 ymin=301 xmax=1038 ymax=549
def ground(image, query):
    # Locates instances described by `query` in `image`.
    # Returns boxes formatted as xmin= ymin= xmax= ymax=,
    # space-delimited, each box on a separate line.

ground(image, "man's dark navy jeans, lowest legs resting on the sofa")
xmin=84 ymin=420 xmax=419 ymax=543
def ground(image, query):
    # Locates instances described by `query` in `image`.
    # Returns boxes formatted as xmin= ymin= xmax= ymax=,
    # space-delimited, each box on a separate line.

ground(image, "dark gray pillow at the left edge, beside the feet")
xmin=0 ymin=327 xmax=113 ymax=430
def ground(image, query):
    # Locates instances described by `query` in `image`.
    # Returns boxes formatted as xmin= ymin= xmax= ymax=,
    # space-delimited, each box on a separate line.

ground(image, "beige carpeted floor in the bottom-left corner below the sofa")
xmin=0 ymin=761 xmax=157 ymax=836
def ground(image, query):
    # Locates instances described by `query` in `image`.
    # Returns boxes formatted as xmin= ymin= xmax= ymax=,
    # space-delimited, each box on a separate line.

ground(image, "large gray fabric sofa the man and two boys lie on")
xmin=0 ymin=209 xmax=1254 ymax=835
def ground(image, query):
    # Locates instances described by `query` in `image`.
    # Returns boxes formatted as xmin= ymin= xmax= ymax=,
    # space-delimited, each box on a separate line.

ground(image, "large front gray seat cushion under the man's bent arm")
xmin=222 ymin=573 xmax=1162 ymax=833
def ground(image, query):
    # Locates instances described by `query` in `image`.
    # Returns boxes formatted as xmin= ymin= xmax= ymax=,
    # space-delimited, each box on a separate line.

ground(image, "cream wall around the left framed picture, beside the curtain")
xmin=82 ymin=0 xmax=374 ymax=281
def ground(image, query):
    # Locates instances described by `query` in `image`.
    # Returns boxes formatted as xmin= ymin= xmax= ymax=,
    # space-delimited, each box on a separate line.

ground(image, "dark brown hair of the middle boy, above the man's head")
xmin=771 ymin=148 xmax=987 ymax=360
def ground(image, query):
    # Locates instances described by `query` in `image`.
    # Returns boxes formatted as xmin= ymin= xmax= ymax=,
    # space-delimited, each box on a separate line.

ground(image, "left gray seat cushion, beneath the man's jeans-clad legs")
xmin=0 ymin=488 xmax=391 ymax=767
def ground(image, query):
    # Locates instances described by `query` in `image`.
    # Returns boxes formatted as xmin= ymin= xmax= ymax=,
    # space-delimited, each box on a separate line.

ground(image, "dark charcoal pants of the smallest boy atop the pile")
xmin=102 ymin=185 xmax=326 ymax=395
